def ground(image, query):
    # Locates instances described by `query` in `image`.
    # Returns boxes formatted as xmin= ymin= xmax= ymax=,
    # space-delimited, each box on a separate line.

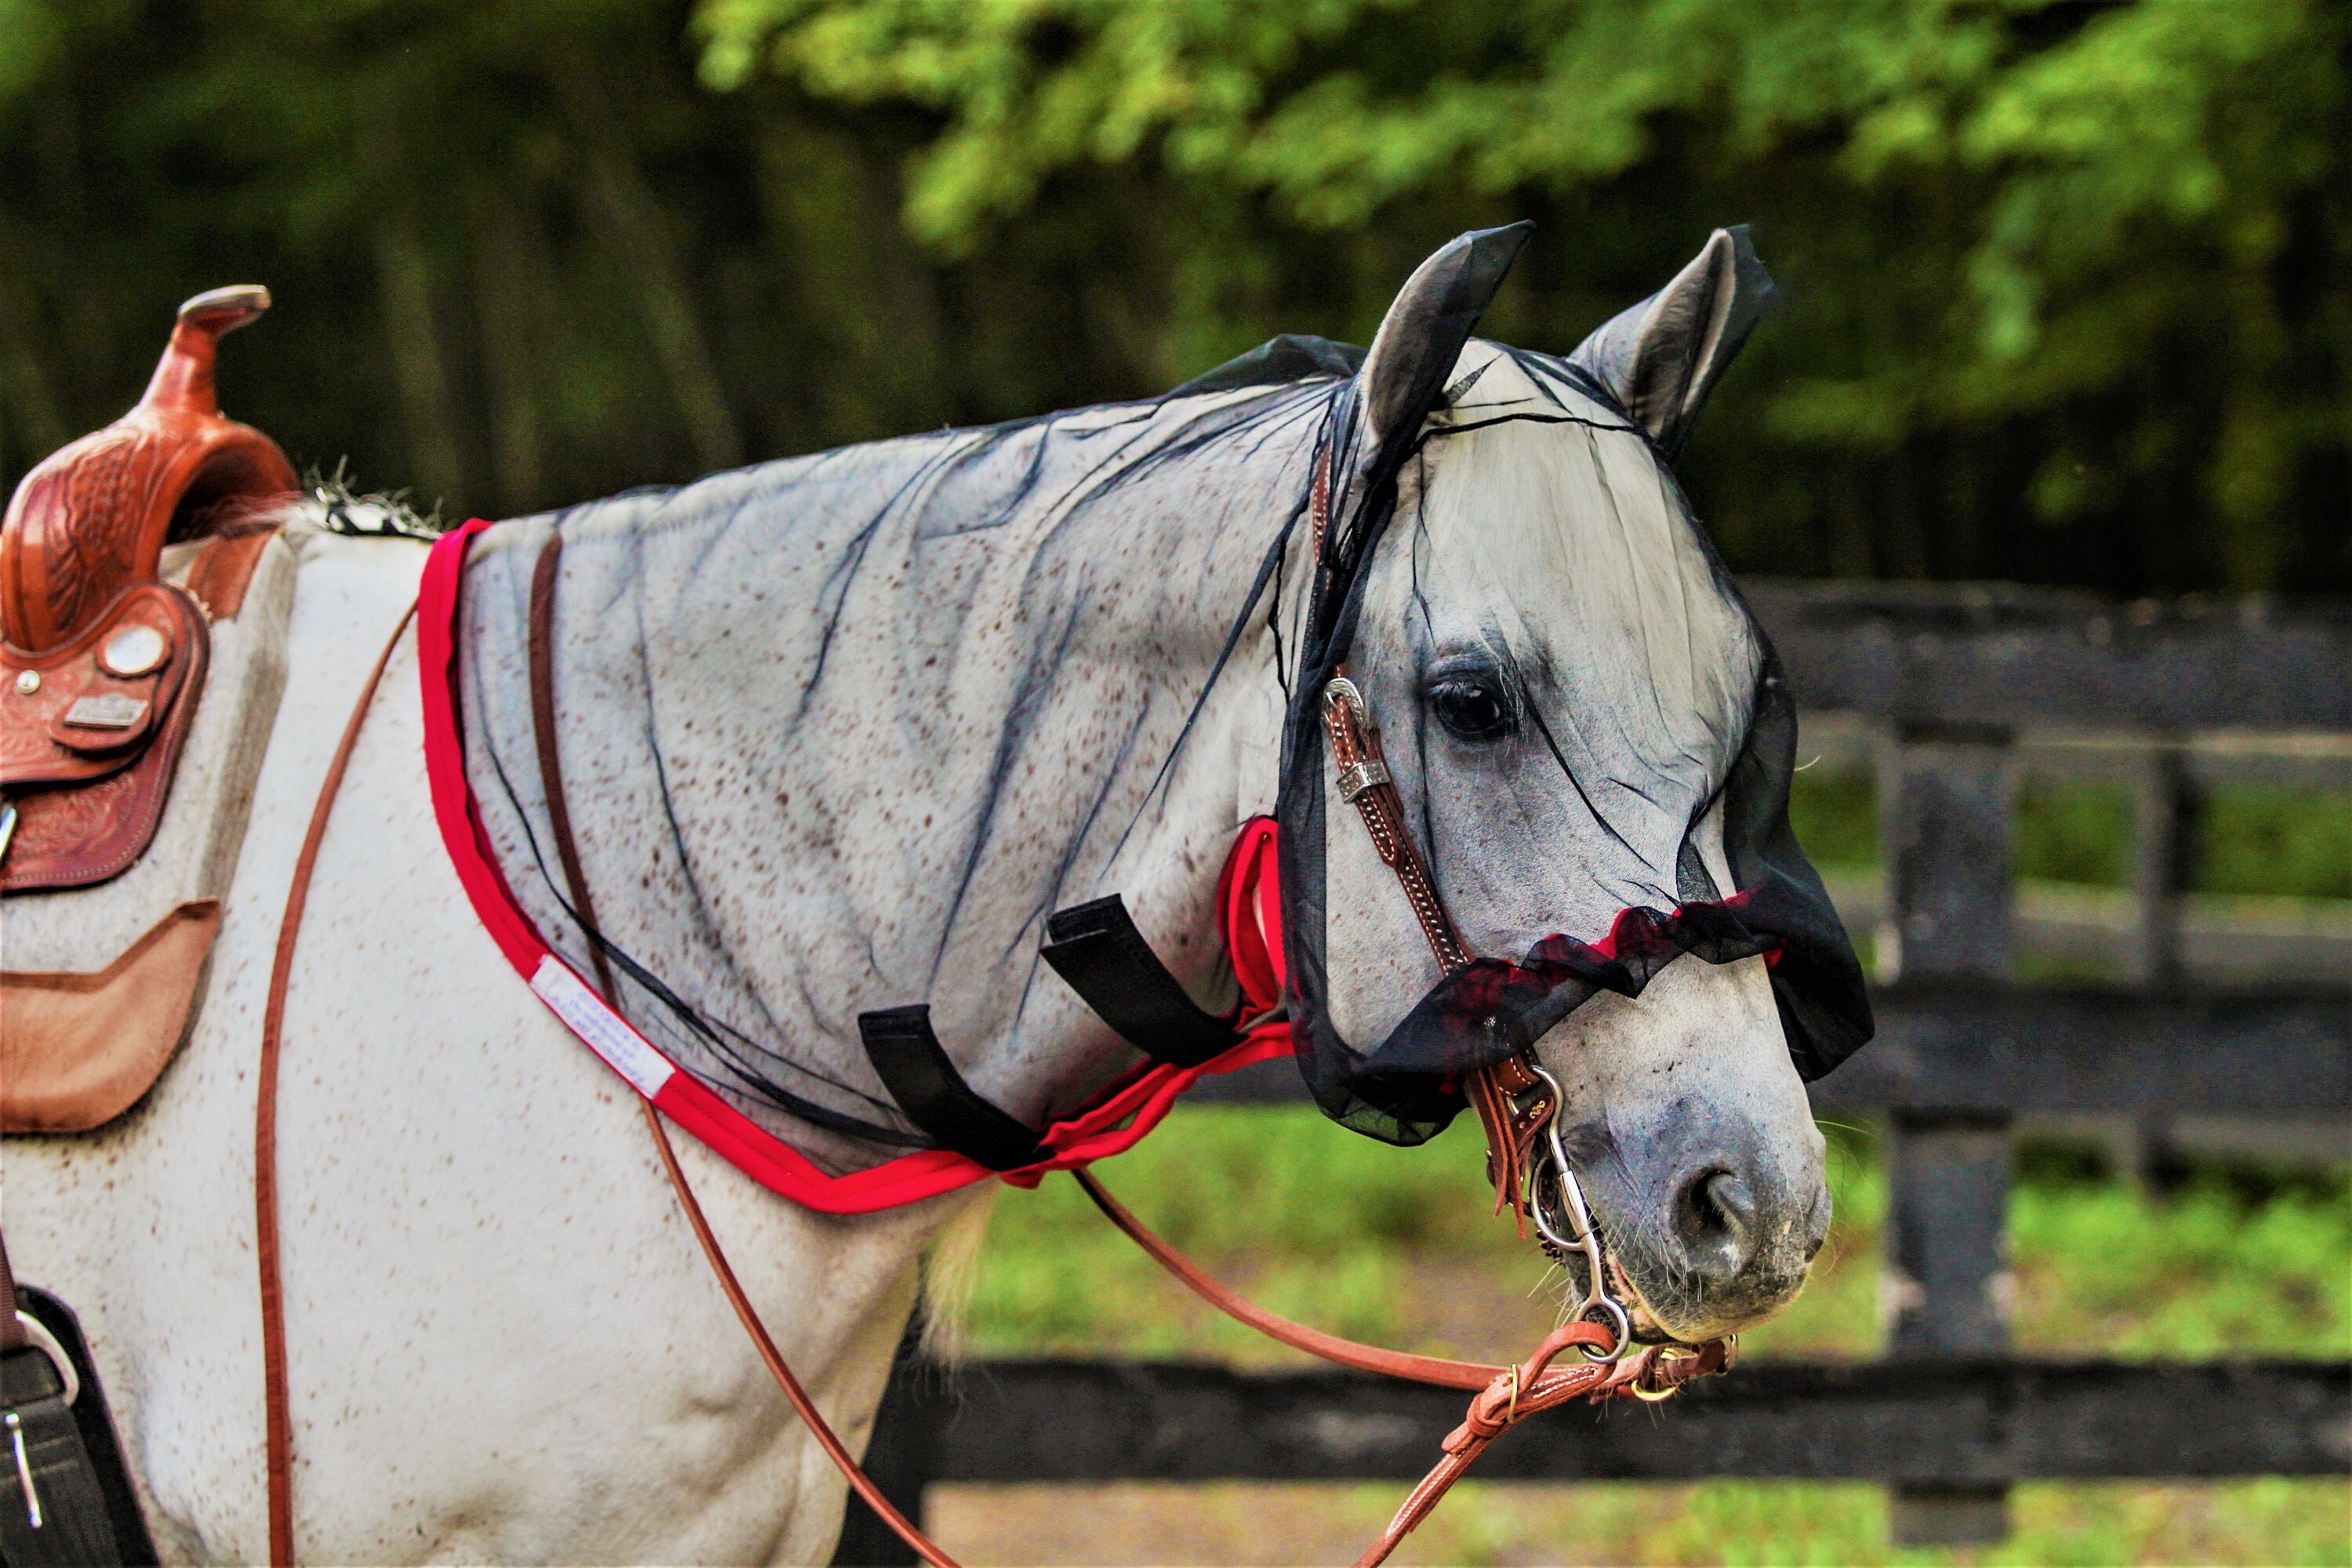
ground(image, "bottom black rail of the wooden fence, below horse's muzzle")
xmin=870 ymin=1359 xmax=2352 ymax=1486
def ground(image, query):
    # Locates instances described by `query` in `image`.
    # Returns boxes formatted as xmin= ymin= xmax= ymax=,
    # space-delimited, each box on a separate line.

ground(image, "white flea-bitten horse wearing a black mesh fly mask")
xmin=5 ymin=235 xmax=1863 ymax=1563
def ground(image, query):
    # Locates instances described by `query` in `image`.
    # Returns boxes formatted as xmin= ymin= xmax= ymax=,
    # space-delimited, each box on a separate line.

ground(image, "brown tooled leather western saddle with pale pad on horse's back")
xmin=0 ymin=289 xmax=294 ymax=1133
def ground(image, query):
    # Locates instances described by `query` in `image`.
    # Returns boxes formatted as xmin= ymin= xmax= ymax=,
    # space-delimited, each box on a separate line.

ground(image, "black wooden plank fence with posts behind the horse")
xmin=837 ymin=583 xmax=2352 ymax=1563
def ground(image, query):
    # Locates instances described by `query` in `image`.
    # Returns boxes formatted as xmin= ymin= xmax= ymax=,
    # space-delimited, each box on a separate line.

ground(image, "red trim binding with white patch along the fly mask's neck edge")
xmin=416 ymin=517 xmax=1291 ymax=1213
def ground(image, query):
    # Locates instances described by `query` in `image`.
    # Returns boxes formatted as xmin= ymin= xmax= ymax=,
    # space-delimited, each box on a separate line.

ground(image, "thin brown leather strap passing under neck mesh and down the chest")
xmin=529 ymin=534 xmax=962 ymax=1568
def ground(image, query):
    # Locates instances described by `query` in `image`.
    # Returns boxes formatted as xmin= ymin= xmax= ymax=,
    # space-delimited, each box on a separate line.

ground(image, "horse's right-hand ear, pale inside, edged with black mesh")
xmin=1569 ymin=223 xmax=1771 ymax=459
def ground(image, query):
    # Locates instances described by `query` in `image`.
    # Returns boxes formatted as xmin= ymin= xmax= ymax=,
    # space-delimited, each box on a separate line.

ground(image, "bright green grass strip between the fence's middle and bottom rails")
xmin=971 ymin=1105 xmax=2352 ymax=1363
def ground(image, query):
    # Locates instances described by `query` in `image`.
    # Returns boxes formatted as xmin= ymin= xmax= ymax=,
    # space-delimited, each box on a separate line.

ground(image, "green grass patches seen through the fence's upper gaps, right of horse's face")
xmin=1790 ymin=769 xmax=2352 ymax=898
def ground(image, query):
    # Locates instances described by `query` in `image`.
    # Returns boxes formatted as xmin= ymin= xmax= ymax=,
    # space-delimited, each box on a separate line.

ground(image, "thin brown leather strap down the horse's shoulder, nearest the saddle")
xmin=254 ymin=604 xmax=416 ymax=1568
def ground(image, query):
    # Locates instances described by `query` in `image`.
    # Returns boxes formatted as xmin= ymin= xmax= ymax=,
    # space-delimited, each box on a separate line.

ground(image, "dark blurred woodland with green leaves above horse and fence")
xmin=0 ymin=0 xmax=2352 ymax=595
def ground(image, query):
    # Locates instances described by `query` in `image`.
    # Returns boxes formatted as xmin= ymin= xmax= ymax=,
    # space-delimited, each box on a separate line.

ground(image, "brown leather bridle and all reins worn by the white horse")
xmin=254 ymin=452 xmax=1733 ymax=1568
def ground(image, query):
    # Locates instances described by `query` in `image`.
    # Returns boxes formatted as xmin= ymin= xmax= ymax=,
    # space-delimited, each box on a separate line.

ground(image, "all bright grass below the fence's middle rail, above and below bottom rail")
xmin=971 ymin=1107 xmax=2352 ymax=1563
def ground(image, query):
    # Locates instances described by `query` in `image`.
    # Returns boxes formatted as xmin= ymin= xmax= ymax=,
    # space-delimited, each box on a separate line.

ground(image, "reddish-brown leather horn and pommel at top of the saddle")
xmin=0 ymin=285 xmax=296 ymax=654
